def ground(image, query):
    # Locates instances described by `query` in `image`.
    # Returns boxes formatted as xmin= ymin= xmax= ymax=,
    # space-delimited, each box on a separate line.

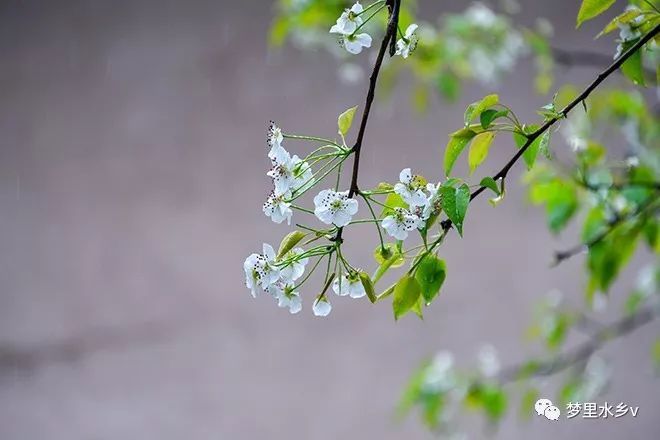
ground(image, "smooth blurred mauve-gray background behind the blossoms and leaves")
xmin=0 ymin=0 xmax=660 ymax=440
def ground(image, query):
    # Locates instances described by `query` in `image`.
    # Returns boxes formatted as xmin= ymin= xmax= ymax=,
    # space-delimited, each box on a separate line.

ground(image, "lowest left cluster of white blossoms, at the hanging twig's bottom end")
xmin=243 ymin=243 xmax=308 ymax=313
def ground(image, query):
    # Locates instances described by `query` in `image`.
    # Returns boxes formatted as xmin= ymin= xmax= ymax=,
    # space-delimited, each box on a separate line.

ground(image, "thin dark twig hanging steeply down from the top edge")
xmin=333 ymin=0 xmax=401 ymax=243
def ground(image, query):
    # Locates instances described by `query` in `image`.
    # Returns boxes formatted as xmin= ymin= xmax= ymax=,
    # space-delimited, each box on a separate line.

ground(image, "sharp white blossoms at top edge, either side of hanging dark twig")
xmin=330 ymin=2 xmax=419 ymax=58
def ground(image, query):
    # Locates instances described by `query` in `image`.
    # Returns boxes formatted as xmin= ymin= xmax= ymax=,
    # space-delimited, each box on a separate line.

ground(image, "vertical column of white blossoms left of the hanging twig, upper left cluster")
xmin=263 ymin=121 xmax=314 ymax=224
